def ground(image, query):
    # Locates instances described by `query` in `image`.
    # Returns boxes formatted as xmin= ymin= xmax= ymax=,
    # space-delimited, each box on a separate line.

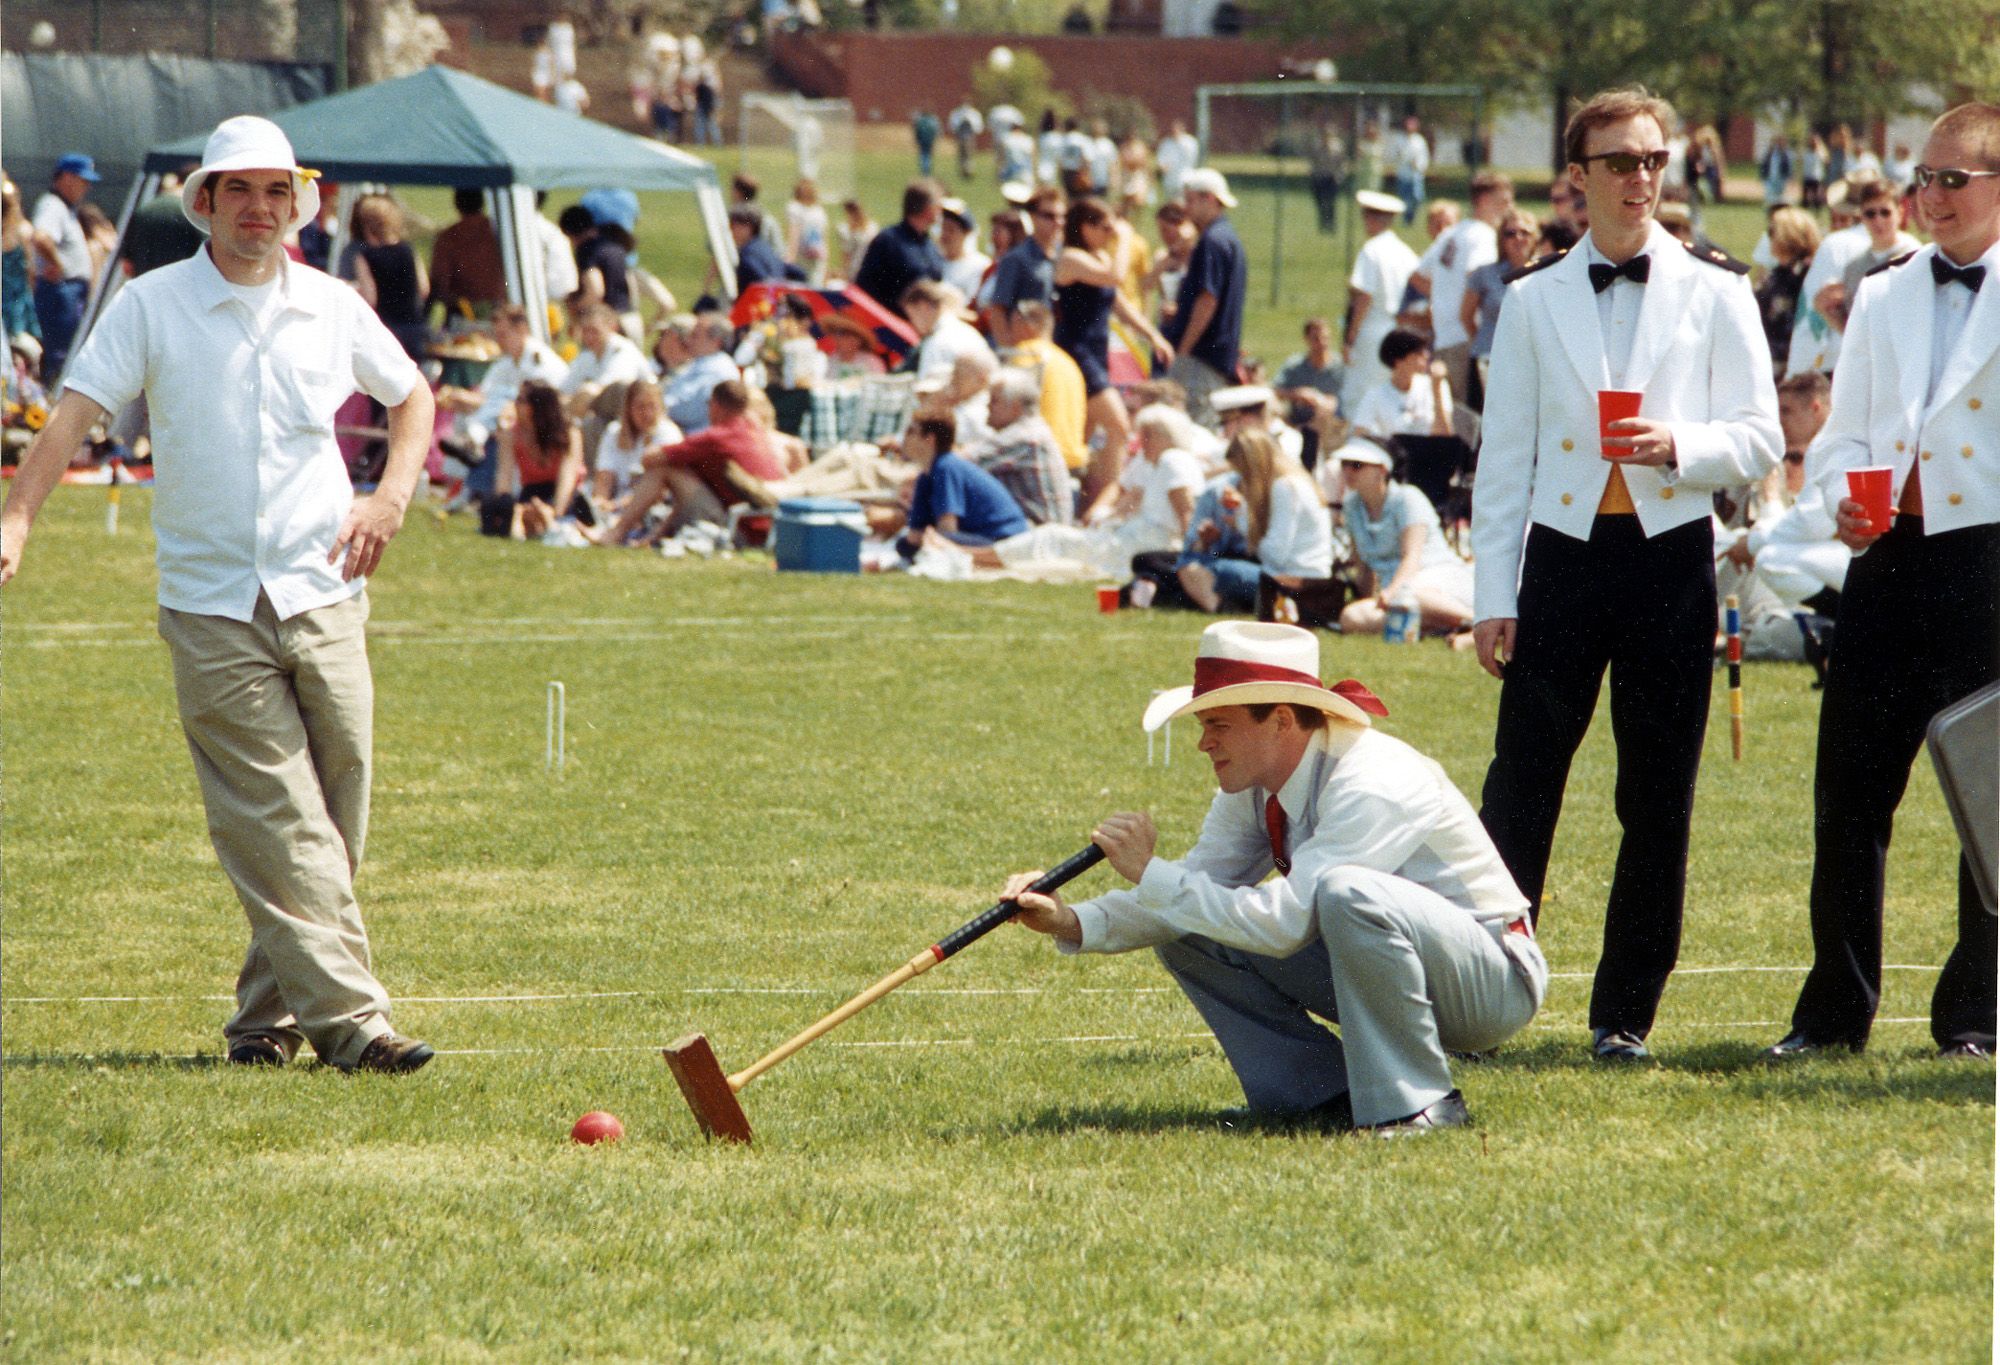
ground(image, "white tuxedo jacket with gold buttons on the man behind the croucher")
xmin=1472 ymin=224 xmax=1784 ymax=620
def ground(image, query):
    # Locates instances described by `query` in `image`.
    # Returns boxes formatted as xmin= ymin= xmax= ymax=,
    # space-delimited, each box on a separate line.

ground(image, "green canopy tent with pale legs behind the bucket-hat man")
xmin=84 ymin=66 xmax=736 ymax=356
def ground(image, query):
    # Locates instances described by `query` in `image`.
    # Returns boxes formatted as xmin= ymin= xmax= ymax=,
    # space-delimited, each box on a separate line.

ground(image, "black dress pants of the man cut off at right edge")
xmin=1792 ymin=516 xmax=2000 ymax=1051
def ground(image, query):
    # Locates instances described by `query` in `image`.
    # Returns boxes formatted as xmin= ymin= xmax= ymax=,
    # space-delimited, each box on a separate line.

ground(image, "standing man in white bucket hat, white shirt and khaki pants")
xmin=0 ymin=116 xmax=434 ymax=1071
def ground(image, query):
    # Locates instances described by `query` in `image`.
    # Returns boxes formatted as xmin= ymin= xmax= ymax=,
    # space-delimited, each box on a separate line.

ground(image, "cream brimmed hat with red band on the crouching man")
xmin=1140 ymin=620 xmax=1388 ymax=731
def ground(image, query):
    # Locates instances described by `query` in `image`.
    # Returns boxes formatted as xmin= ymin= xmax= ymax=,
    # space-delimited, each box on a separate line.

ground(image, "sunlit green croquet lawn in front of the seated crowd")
xmin=0 ymin=488 xmax=1994 ymax=1361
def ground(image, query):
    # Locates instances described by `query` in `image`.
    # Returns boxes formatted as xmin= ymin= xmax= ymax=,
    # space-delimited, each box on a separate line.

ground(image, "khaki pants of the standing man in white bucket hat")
xmin=160 ymin=592 xmax=390 ymax=1065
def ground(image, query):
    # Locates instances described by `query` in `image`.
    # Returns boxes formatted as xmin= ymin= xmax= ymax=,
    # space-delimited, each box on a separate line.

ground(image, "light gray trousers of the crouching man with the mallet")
xmin=1156 ymin=867 xmax=1548 ymax=1125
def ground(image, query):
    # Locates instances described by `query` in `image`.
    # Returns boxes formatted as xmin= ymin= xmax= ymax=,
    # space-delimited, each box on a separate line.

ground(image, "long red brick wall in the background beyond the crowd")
xmin=772 ymin=32 xmax=1338 ymax=137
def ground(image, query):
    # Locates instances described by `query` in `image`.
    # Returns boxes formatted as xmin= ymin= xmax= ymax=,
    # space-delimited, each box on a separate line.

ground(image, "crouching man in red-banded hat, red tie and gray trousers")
xmin=1006 ymin=620 xmax=1548 ymax=1137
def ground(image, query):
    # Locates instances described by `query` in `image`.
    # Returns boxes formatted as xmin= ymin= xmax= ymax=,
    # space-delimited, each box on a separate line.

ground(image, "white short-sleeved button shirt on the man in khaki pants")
xmin=68 ymin=250 xmax=422 ymax=620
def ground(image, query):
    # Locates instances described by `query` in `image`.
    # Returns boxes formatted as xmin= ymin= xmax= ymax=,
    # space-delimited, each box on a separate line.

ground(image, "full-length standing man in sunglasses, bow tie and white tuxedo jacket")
xmin=1472 ymin=90 xmax=1780 ymax=1061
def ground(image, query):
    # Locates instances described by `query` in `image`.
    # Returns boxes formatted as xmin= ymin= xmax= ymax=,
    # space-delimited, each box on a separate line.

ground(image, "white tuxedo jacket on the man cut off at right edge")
xmin=1808 ymin=246 xmax=2000 ymax=534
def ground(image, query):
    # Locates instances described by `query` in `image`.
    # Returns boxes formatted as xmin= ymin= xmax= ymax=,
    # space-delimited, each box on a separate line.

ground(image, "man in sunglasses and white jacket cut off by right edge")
xmin=1764 ymin=104 xmax=2000 ymax=1061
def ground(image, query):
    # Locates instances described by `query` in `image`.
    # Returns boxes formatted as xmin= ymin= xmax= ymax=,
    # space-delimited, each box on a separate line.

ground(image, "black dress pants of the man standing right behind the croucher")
xmin=1480 ymin=514 xmax=1716 ymax=1037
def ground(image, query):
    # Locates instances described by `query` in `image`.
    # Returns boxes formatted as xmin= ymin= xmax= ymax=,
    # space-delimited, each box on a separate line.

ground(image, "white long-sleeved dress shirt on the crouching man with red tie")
xmin=1062 ymin=721 xmax=1528 ymax=957
